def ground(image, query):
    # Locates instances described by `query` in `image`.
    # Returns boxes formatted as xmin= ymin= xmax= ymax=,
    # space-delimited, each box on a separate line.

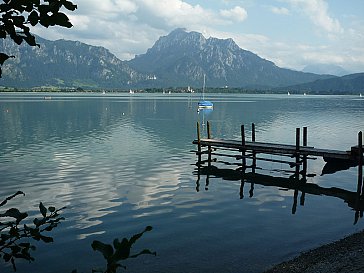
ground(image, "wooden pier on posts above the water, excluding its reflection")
xmin=193 ymin=122 xmax=363 ymax=171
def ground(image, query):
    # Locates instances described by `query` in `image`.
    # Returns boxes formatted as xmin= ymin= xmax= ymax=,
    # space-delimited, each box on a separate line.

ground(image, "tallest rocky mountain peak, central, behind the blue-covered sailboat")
xmin=127 ymin=29 xmax=331 ymax=88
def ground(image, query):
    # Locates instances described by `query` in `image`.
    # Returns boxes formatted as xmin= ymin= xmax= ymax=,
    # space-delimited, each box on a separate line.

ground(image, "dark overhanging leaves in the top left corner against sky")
xmin=0 ymin=0 xmax=77 ymax=78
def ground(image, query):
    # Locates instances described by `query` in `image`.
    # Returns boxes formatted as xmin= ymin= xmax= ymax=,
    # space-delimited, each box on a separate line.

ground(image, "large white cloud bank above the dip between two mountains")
xmin=34 ymin=0 xmax=247 ymax=60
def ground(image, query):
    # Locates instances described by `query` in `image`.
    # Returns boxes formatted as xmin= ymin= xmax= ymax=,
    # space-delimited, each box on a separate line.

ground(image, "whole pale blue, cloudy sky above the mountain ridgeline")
xmin=33 ymin=0 xmax=364 ymax=73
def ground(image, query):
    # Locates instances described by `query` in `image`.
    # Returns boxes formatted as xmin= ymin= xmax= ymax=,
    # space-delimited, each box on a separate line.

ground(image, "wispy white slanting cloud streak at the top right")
xmin=286 ymin=0 xmax=343 ymax=34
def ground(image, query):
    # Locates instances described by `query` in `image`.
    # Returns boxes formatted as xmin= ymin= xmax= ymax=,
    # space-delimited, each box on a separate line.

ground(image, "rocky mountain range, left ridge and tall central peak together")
xmin=0 ymin=29 xmax=346 ymax=89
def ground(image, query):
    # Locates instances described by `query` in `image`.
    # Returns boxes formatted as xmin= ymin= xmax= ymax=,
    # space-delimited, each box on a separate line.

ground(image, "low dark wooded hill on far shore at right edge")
xmin=278 ymin=73 xmax=364 ymax=94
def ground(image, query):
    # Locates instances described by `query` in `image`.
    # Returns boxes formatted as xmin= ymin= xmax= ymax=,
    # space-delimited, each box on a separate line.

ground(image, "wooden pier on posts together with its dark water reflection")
xmin=193 ymin=122 xmax=364 ymax=223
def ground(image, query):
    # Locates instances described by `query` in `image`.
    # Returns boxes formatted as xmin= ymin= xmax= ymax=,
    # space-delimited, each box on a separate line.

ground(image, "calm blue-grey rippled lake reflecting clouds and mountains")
xmin=0 ymin=93 xmax=364 ymax=273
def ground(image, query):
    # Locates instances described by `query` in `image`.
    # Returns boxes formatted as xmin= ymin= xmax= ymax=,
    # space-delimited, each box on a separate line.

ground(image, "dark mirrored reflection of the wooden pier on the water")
xmin=194 ymin=164 xmax=364 ymax=224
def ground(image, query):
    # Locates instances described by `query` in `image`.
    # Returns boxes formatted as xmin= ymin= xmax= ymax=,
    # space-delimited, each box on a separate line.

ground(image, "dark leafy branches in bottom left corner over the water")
xmin=0 ymin=191 xmax=65 ymax=271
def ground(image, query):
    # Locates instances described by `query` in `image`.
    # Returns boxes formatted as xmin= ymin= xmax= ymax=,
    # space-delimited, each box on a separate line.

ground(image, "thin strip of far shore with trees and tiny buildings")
xmin=0 ymin=87 xmax=364 ymax=95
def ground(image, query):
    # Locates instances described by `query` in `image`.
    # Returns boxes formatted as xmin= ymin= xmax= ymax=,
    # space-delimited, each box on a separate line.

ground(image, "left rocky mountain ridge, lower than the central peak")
xmin=0 ymin=37 xmax=145 ymax=88
